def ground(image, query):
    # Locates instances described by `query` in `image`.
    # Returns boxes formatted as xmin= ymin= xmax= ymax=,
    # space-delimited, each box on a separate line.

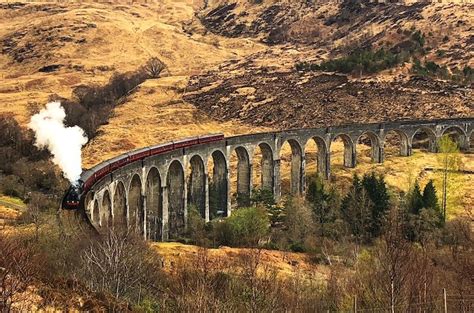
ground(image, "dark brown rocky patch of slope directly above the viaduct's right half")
xmin=185 ymin=69 xmax=474 ymax=129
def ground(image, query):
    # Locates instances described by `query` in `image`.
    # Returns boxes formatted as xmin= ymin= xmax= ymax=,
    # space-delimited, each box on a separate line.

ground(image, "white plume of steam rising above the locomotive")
xmin=28 ymin=102 xmax=87 ymax=184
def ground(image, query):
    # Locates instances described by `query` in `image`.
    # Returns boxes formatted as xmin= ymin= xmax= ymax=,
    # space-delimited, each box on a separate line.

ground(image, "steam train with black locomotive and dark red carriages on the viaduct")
xmin=62 ymin=134 xmax=224 ymax=210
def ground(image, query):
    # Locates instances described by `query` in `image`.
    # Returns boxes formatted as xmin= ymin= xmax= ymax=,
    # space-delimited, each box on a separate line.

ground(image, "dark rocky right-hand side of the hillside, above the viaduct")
xmin=185 ymin=1 xmax=474 ymax=129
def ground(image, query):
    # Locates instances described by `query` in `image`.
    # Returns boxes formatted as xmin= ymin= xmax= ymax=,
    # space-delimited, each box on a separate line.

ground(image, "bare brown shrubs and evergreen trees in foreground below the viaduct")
xmin=0 ymin=133 xmax=474 ymax=312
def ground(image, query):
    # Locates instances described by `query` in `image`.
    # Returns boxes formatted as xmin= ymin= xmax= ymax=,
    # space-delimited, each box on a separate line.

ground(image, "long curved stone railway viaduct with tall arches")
xmin=76 ymin=118 xmax=474 ymax=240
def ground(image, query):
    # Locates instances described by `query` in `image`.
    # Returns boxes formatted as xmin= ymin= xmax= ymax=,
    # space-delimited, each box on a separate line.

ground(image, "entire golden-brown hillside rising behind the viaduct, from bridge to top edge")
xmin=0 ymin=0 xmax=474 ymax=167
